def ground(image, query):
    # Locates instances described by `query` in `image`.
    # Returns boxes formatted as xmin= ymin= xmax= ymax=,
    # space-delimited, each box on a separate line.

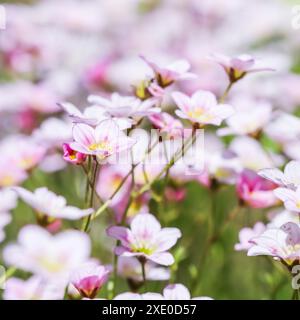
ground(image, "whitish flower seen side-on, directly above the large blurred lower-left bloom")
xmin=14 ymin=187 xmax=94 ymax=220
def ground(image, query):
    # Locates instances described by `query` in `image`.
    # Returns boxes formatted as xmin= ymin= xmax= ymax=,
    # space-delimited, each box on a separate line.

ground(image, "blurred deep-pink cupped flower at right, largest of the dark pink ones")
xmin=236 ymin=169 xmax=278 ymax=208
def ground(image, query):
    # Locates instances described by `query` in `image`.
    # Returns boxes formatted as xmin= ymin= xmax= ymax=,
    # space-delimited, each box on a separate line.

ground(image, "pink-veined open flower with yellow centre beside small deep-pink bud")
xmin=70 ymin=120 xmax=135 ymax=160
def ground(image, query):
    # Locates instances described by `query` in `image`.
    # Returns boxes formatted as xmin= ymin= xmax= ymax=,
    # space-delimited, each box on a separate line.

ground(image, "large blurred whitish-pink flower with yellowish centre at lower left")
xmin=3 ymin=225 xmax=91 ymax=285
